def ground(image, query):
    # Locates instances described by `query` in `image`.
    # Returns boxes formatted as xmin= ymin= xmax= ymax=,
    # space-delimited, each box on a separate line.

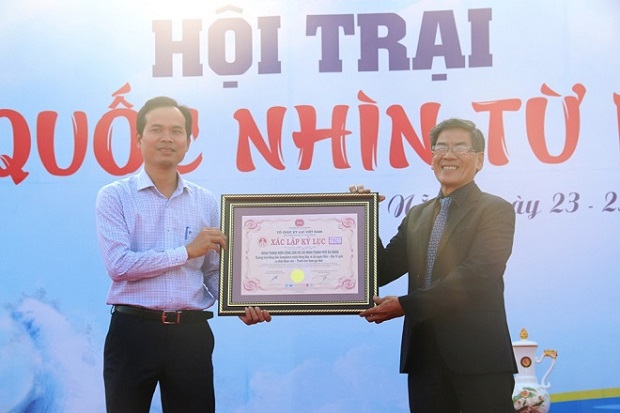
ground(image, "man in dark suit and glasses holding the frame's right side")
xmin=350 ymin=119 xmax=517 ymax=413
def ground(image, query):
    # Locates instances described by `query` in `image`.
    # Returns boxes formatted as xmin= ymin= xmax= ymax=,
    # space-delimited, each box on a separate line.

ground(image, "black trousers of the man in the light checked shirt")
xmin=103 ymin=312 xmax=215 ymax=413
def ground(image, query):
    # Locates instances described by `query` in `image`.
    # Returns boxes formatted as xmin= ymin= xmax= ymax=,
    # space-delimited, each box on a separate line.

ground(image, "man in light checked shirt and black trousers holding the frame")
xmin=96 ymin=96 xmax=271 ymax=413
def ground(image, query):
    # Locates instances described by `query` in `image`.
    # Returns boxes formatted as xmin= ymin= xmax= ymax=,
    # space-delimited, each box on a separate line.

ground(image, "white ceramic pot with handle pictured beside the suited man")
xmin=512 ymin=329 xmax=558 ymax=413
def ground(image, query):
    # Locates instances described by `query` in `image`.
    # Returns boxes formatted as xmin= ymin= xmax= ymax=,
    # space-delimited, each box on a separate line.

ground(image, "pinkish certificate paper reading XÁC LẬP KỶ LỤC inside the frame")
xmin=241 ymin=214 xmax=359 ymax=295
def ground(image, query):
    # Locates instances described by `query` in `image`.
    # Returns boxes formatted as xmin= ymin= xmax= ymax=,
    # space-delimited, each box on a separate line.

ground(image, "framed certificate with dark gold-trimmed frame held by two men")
xmin=218 ymin=193 xmax=378 ymax=315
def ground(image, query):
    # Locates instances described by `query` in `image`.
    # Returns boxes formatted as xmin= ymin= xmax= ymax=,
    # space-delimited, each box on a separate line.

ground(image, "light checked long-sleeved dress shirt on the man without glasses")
xmin=96 ymin=169 xmax=220 ymax=310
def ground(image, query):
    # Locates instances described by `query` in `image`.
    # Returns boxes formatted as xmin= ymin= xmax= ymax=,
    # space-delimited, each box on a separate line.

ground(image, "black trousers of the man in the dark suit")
xmin=408 ymin=332 xmax=515 ymax=413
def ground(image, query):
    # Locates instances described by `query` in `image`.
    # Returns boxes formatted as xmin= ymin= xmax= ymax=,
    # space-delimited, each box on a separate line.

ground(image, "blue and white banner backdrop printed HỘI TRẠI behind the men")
xmin=0 ymin=0 xmax=620 ymax=413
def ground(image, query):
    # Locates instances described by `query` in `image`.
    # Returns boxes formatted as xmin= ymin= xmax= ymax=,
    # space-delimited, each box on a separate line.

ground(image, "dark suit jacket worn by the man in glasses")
xmin=378 ymin=182 xmax=517 ymax=374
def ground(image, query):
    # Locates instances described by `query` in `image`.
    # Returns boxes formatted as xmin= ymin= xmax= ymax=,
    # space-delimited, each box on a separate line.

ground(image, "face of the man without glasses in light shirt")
xmin=137 ymin=106 xmax=189 ymax=171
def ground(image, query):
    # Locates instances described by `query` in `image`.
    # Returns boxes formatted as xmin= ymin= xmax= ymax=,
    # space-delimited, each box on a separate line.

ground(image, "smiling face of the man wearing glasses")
xmin=431 ymin=128 xmax=484 ymax=195
